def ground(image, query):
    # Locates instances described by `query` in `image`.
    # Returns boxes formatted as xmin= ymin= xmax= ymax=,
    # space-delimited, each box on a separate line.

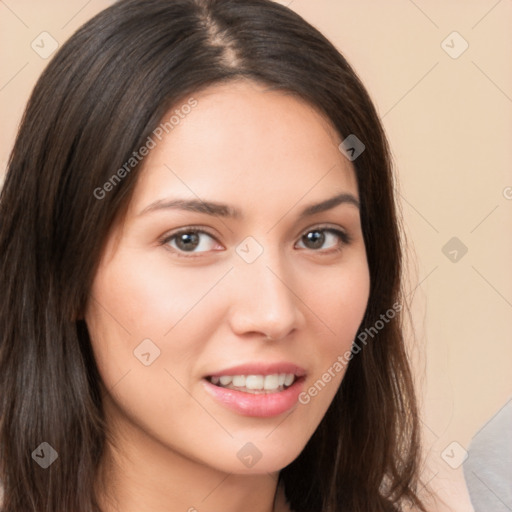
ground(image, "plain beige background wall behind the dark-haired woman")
xmin=0 ymin=0 xmax=512 ymax=511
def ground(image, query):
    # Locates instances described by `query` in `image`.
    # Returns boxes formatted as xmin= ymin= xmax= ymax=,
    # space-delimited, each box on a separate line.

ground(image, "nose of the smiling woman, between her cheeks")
xmin=229 ymin=250 xmax=305 ymax=340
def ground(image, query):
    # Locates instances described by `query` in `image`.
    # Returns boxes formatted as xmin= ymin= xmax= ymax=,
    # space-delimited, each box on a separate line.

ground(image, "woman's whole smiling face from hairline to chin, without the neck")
xmin=85 ymin=82 xmax=369 ymax=474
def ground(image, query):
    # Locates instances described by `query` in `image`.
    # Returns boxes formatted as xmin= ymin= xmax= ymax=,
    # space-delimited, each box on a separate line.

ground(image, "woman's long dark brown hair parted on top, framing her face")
xmin=0 ymin=0 xmax=425 ymax=512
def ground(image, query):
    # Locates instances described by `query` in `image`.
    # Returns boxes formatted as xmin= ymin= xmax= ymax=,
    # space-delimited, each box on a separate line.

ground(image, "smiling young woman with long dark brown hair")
xmin=0 ymin=0 xmax=425 ymax=512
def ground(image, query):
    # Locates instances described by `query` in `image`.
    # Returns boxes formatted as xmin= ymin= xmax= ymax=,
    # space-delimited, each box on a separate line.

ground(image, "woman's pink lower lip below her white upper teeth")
xmin=203 ymin=377 xmax=304 ymax=418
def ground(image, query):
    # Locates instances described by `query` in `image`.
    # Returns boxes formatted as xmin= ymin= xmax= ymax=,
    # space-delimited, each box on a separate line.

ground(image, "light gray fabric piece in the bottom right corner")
xmin=463 ymin=399 xmax=512 ymax=512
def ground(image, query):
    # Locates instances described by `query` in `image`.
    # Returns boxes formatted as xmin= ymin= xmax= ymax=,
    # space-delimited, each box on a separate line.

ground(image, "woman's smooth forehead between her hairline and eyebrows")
xmin=126 ymin=81 xmax=357 ymax=215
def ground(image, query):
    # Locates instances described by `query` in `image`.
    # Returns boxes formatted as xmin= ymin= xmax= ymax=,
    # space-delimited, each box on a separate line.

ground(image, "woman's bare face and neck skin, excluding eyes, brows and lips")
xmin=85 ymin=81 xmax=370 ymax=512
